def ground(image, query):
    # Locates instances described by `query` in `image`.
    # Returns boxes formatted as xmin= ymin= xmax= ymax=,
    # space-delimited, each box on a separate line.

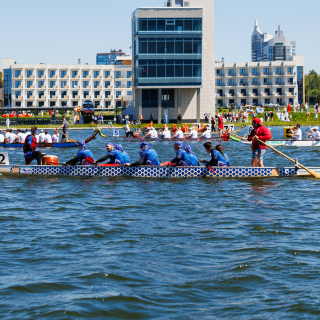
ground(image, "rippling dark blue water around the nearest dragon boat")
xmin=0 ymin=128 xmax=320 ymax=319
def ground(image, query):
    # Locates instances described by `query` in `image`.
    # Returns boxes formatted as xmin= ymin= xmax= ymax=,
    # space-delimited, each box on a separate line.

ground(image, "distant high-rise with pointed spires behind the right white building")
xmin=251 ymin=20 xmax=296 ymax=62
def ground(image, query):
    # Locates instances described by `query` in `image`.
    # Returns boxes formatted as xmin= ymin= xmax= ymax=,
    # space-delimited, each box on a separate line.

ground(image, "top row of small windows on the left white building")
xmin=14 ymin=70 xmax=132 ymax=78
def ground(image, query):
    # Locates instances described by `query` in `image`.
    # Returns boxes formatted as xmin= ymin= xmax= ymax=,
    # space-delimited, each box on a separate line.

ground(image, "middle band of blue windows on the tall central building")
xmin=136 ymin=38 xmax=202 ymax=55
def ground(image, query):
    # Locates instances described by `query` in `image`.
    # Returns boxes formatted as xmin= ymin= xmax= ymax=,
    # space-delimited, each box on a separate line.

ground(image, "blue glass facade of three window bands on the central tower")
xmin=133 ymin=18 xmax=202 ymax=87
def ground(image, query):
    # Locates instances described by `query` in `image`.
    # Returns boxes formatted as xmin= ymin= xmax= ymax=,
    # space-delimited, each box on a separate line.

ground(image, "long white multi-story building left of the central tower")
xmin=2 ymin=56 xmax=132 ymax=109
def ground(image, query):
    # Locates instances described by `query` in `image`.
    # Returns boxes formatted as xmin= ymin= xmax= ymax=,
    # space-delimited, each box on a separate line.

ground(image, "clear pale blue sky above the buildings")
xmin=0 ymin=0 xmax=320 ymax=72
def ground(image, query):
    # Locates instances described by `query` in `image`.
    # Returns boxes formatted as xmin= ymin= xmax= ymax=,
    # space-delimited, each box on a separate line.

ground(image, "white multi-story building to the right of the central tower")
xmin=215 ymin=56 xmax=305 ymax=108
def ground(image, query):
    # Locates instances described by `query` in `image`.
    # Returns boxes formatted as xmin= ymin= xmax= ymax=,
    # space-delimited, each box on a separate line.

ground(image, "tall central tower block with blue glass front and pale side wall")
xmin=132 ymin=0 xmax=215 ymax=123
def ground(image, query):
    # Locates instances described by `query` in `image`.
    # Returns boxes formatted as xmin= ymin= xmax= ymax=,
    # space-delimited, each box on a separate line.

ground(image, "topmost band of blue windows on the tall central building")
xmin=134 ymin=18 xmax=202 ymax=33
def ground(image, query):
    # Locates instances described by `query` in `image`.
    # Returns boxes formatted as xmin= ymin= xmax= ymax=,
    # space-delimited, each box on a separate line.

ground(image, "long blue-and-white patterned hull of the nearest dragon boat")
xmin=0 ymin=165 xmax=320 ymax=179
